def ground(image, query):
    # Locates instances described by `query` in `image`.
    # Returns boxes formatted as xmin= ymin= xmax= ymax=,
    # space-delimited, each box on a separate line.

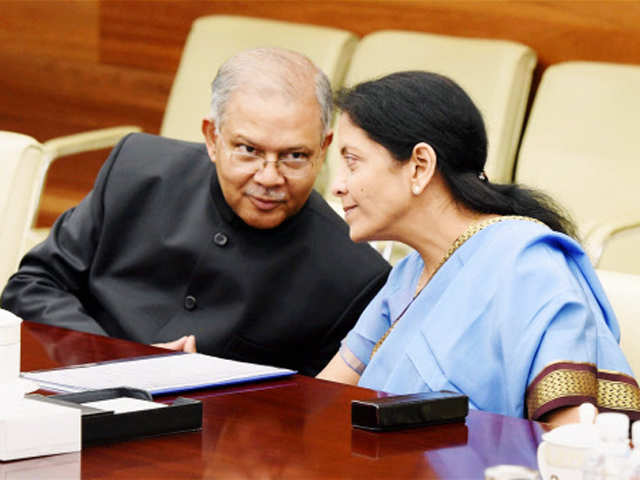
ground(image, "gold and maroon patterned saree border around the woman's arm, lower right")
xmin=525 ymin=361 xmax=640 ymax=420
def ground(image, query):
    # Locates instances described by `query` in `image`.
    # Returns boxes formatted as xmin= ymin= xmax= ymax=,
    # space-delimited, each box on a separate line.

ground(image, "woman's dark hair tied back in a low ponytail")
xmin=336 ymin=71 xmax=576 ymax=238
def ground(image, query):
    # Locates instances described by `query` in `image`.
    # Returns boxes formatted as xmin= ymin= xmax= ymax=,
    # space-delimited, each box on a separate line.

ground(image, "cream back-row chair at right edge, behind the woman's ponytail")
xmin=515 ymin=62 xmax=640 ymax=273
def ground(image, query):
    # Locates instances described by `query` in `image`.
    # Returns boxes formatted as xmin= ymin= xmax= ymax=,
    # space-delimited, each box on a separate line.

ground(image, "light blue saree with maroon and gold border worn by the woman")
xmin=341 ymin=219 xmax=640 ymax=419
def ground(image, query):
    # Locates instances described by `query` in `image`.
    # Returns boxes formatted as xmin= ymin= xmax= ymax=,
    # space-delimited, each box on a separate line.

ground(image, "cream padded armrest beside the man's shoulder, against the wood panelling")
xmin=43 ymin=125 xmax=142 ymax=160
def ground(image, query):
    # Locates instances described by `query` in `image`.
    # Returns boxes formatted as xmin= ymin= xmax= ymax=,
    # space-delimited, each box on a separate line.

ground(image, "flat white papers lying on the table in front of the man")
xmin=22 ymin=353 xmax=295 ymax=394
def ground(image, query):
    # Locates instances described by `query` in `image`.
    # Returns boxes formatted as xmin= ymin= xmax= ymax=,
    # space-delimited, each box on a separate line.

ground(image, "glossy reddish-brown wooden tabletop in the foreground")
xmin=13 ymin=322 xmax=544 ymax=479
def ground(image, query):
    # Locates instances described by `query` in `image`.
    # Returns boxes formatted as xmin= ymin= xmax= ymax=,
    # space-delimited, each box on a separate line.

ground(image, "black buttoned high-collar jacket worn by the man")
xmin=2 ymin=134 xmax=389 ymax=375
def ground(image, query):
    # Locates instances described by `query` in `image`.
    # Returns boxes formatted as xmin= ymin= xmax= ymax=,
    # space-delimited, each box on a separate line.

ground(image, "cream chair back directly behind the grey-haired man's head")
xmin=160 ymin=15 xmax=357 ymax=146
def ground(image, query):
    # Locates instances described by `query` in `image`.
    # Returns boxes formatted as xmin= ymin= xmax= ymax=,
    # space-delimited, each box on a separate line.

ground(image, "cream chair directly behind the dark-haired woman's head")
xmin=328 ymin=31 xmax=536 ymax=263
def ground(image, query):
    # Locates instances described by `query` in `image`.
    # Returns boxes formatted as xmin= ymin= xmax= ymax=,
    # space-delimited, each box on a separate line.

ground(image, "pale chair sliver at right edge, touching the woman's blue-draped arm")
xmin=597 ymin=270 xmax=640 ymax=375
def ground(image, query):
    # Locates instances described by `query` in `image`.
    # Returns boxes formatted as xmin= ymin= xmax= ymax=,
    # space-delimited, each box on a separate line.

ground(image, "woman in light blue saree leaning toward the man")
xmin=319 ymin=72 xmax=640 ymax=423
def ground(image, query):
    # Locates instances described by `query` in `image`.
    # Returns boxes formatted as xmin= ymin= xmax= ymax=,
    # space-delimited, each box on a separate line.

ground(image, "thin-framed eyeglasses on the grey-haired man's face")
xmin=220 ymin=136 xmax=313 ymax=178
